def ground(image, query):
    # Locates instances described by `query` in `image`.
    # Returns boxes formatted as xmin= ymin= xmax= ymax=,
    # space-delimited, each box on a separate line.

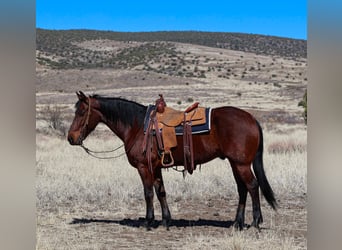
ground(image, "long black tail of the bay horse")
xmin=253 ymin=121 xmax=277 ymax=210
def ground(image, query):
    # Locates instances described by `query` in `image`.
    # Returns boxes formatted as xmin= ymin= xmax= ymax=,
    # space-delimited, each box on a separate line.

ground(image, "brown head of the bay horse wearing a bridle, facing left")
xmin=68 ymin=91 xmax=101 ymax=145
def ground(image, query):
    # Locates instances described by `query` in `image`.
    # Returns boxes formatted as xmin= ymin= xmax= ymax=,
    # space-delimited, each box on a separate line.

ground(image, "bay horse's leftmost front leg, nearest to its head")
xmin=138 ymin=166 xmax=154 ymax=230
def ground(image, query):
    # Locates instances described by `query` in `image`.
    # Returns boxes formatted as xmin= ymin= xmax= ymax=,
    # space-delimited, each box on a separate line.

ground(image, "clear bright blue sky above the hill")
xmin=36 ymin=0 xmax=307 ymax=39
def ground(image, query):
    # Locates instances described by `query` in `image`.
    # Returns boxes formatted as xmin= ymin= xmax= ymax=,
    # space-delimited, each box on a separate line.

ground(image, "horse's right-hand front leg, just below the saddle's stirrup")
xmin=154 ymin=168 xmax=171 ymax=229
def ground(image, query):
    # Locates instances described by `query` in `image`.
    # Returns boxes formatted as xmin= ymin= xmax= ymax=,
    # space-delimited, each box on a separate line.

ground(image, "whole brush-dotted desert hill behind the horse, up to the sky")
xmin=36 ymin=29 xmax=307 ymax=131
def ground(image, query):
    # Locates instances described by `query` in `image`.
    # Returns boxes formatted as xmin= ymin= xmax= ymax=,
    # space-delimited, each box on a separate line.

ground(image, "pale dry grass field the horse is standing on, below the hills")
xmin=37 ymin=131 xmax=307 ymax=249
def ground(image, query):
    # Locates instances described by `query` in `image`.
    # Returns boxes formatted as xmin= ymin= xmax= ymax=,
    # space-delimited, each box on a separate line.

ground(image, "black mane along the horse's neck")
xmin=90 ymin=95 xmax=147 ymax=127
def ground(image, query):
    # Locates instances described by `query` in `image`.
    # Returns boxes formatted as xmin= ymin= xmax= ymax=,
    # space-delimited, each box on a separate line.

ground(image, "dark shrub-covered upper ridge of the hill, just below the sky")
xmin=36 ymin=29 xmax=306 ymax=69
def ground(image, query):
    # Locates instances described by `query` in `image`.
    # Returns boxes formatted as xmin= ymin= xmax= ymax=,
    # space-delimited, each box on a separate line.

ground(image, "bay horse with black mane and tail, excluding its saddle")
xmin=67 ymin=91 xmax=277 ymax=230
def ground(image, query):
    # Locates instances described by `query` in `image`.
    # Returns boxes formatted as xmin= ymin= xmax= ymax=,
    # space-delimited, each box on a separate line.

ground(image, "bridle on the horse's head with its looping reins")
xmin=80 ymin=97 xmax=134 ymax=159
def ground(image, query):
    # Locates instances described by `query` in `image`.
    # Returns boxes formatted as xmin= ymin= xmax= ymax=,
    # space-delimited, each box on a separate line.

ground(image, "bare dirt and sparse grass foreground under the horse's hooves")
xmin=38 ymin=195 xmax=307 ymax=249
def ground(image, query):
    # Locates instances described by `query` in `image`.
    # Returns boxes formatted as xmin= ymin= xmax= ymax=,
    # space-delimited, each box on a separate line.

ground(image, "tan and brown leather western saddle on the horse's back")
xmin=143 ymin=94 xmax=206 ymax=174
